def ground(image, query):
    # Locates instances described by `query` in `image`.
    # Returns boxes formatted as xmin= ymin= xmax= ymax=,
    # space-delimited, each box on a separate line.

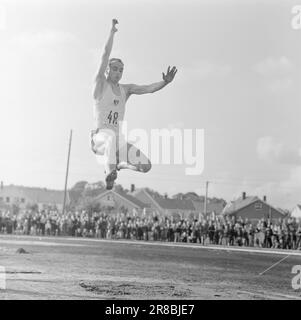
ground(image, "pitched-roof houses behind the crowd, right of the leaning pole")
xmin=96 ymin=188 xmax=301 ymax=221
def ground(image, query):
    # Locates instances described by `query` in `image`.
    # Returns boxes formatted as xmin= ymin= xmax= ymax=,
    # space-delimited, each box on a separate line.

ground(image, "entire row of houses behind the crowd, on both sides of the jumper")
xmin=0 ymin=183 xmax=301 ymax=220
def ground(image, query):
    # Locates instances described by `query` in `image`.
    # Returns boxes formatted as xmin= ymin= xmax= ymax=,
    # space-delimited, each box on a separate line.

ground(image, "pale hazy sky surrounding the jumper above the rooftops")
xmin=0 ymin=0 xmax=301 ymax=208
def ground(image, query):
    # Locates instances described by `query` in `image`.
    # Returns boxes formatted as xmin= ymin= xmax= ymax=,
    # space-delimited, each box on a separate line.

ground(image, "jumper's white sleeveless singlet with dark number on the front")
xmin=93 ymin=82 xmax=126 ymax=135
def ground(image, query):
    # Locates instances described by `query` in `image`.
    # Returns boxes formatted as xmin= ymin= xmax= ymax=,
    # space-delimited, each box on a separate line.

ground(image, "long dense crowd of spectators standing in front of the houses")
xmin=0 ymin=210 xmax=301 ymax=250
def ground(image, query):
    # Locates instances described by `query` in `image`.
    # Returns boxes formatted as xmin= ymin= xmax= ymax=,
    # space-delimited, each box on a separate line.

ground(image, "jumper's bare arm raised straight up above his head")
xmin=94 ymin=19 xmax=118 ymax=98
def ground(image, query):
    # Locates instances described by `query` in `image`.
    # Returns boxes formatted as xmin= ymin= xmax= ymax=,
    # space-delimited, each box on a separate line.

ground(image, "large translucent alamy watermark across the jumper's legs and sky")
xmin=93 ymin=120 xmax=205 ymax=175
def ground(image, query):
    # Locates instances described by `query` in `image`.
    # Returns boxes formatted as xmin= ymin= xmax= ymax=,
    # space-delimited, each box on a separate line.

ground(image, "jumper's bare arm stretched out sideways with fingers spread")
xmin=124 ymin=66 xmax=178 ymax=97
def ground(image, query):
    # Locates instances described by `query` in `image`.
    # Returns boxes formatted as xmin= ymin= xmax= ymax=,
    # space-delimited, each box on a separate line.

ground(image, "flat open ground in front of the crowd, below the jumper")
xmin=0 ymin=235 xmax=301 ymax=300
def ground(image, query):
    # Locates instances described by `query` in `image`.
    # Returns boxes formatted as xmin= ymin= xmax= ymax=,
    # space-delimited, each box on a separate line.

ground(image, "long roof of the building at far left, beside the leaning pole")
xmin=3 ymin=185 xmax=68 ymax=204
